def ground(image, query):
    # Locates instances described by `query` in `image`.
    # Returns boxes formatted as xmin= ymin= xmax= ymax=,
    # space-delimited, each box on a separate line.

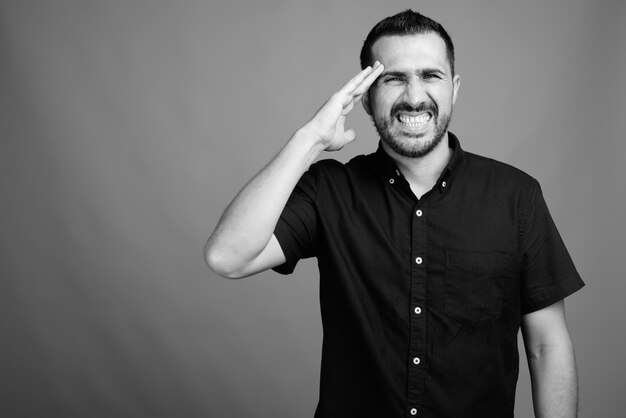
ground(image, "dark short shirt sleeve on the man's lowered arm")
xmin=520 ymin=181 xmax=585 ymax=314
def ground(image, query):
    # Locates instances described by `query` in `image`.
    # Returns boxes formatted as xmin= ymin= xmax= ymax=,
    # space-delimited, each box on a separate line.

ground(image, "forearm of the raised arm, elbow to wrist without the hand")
xmin=205 ymin=128 xmax=323 ymax=276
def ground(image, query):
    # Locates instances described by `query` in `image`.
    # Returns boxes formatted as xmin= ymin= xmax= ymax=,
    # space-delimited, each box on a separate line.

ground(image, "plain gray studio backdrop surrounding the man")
xmin=0 ymin=0 xmax=626 ymax=418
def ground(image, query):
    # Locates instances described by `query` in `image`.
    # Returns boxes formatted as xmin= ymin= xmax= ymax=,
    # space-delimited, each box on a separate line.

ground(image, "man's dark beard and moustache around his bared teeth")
xmin=372 ymin=103 xmax=452 ymax=158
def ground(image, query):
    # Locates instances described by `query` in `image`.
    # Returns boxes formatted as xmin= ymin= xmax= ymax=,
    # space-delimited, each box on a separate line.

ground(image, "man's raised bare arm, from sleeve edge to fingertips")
xmin=204 ymin=62 xmax=383 ymax=278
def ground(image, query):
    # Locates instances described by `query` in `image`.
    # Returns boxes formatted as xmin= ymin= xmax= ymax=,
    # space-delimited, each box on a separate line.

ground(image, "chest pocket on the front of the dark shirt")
xmin=444 ymin=250 xmax=510 ymax=326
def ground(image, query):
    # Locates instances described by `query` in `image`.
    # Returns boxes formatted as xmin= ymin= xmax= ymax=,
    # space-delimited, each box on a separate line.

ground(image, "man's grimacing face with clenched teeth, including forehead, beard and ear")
xmin=363 ymin=33 xmax=460 ymax=158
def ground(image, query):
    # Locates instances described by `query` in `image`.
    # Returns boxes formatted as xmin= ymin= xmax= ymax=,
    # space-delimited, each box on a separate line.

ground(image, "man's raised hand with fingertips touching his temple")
xmin=303 ymin=61 xmax=384 ymax=151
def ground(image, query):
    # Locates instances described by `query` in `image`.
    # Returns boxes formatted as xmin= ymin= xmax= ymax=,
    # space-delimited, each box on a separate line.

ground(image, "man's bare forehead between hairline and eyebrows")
xmin=372 ymin=32 xmax=450 ymax=72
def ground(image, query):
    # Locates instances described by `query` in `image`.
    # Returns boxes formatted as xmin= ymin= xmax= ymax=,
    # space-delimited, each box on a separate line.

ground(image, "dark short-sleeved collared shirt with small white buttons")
xmin=275 ymin=134 xmax=584 ymax=418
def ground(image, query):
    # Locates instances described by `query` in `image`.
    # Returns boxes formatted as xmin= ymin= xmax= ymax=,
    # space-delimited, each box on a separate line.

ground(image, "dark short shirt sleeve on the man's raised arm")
xmin=273 ymin=163 xmax=321 ymax=274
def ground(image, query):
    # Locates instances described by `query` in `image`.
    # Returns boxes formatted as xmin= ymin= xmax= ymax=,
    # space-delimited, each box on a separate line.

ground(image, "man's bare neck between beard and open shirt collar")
xmin=382 ymin=132 xmax=452 ymax=199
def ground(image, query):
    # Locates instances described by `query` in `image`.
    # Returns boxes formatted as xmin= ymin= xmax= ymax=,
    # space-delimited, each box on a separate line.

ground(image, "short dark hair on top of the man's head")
xmin=360 ymin=9 xmax=454 ymax=74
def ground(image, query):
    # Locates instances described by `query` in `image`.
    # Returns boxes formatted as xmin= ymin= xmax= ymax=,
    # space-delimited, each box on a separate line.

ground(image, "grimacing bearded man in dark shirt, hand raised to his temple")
xmin=205 ymin=10 xmax=584 ymax=417
